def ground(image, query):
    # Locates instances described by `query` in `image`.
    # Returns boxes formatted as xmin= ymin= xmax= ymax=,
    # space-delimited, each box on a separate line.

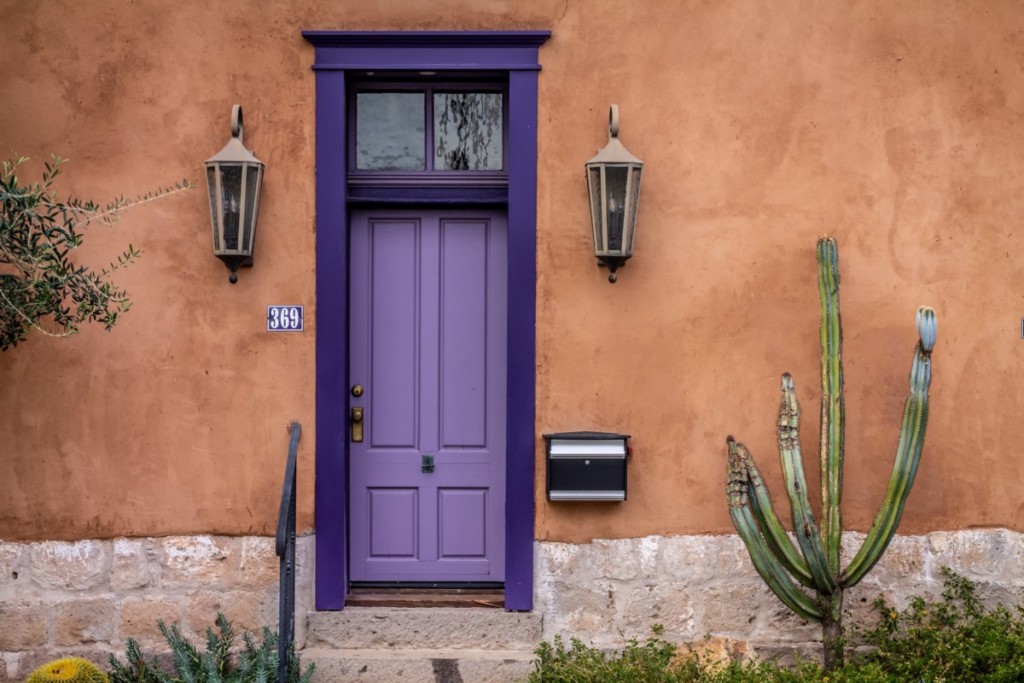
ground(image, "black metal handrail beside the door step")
xmin=275 ymin=422 xmax=302 ymax=683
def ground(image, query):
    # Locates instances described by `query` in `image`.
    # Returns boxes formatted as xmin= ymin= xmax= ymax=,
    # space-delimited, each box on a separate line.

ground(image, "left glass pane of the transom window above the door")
xmin=355 ymin=92 xmax=426 ymax=171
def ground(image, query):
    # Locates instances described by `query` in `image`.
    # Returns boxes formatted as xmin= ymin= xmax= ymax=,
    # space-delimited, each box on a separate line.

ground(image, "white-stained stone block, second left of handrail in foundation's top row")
xmin=160 ymin=536 xmax=239 ymax=589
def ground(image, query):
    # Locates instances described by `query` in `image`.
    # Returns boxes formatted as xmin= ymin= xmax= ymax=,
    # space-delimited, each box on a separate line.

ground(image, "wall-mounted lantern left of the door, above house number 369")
xmin=206 ymin=104 xmax=263 ymax=285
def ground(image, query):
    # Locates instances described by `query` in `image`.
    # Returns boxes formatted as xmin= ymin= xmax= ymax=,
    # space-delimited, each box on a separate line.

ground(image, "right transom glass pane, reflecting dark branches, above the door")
xmin=433 ymin=92 xmax=504 ymax=171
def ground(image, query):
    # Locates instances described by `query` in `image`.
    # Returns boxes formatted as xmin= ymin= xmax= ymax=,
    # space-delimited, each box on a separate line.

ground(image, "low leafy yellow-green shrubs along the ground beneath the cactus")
xmin=528 ymin=568 xmax=1024 ymax=683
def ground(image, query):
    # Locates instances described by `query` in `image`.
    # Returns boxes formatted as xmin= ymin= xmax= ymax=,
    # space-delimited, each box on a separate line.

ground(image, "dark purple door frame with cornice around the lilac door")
xmin=302 ymin=31 xmax=551 ymax=610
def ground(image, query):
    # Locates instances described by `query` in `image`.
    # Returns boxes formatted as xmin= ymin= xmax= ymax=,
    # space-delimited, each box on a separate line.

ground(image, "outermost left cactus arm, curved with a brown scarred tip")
xmin=727 ymin=437 xmax=822 ymax=622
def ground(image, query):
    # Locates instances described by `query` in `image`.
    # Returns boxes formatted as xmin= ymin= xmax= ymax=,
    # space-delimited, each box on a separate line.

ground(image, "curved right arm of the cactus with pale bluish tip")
xmin=842 ymin=308 xmax=936 ymax=588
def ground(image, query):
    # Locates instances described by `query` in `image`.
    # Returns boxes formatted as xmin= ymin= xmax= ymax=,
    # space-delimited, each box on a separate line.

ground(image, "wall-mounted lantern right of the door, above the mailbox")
xmin=587 ymin=104 xmax=643 ymax=283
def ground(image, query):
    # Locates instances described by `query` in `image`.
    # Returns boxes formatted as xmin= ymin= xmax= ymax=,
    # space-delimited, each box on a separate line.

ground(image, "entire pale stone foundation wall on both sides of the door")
xmin=0 ymin=529 xmax=1024 ymax=681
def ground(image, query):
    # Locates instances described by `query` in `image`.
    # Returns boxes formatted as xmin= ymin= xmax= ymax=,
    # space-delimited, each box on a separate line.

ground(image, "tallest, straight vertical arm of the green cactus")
xmin=817 ymin=238 xmax=846 ymax=577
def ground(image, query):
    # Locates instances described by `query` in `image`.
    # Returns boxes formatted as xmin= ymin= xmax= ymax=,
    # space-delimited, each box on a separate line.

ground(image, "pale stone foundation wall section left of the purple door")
xmin=0 ymin=536 xmax=313 ymax=681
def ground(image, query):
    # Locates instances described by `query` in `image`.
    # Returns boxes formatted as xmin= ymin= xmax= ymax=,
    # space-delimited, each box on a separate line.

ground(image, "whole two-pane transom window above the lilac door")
xmin=349 ymin=84 xmax=507 ymax=174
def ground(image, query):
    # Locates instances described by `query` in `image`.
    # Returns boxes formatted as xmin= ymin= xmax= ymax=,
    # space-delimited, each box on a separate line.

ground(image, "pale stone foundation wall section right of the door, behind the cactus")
xmin=535 ymin=529 xmax=1024 ymax=656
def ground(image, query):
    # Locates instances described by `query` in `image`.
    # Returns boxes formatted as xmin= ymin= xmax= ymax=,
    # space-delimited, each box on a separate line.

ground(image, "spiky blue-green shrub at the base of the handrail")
xmin=111 ymin=613 xmax=314 ymax=683
